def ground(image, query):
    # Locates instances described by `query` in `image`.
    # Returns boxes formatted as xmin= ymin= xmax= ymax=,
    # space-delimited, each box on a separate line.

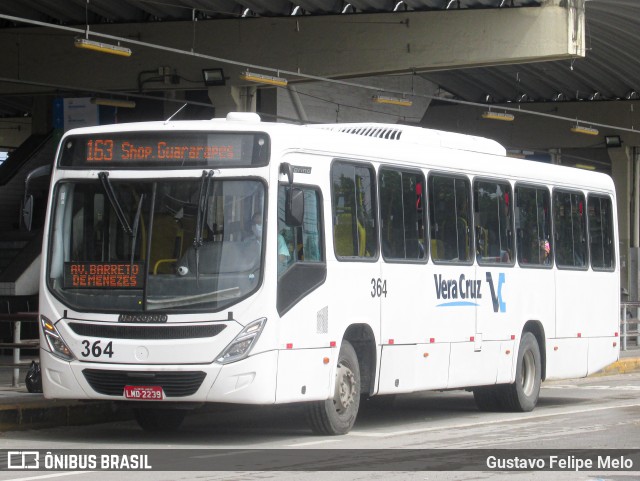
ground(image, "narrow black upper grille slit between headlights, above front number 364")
xmin=69 ymin=322 xmax=227 ymax=340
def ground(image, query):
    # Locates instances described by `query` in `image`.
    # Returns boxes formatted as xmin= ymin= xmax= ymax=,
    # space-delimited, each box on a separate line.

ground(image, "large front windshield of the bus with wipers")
xmin=48 ymin=175 xmax=264 ymax=313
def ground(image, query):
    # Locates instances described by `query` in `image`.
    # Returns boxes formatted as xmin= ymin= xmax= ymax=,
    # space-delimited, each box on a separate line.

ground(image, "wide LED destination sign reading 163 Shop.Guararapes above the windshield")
xmin=60 ymin=131 xmax=269 ymax=168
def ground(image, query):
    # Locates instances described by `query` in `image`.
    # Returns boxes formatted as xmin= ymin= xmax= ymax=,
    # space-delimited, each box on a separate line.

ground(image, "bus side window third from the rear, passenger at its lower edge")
xmin=514 ymin=185 xmax=553 ymax=266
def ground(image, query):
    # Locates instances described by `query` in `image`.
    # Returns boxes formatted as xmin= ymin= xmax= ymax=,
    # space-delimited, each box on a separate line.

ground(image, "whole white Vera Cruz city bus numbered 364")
xmin=40 ymin=113 xmax=620 ymax=434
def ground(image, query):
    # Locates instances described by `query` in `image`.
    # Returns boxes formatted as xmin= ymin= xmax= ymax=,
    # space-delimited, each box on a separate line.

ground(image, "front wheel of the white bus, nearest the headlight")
xmin=307 ymin=341 xmax=360 ymax=435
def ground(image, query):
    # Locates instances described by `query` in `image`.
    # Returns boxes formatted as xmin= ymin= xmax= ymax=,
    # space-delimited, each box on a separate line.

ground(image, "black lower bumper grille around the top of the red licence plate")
xmin=82 ymin=369 xmax=207 ymax=397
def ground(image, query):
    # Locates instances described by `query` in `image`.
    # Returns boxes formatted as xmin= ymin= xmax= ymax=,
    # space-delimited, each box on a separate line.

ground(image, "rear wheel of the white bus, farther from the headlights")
xmin=502 ymin=332 xmax=542 ymax=412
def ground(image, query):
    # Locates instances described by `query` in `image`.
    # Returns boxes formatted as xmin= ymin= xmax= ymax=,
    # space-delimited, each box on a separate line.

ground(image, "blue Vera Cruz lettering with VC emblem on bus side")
xmin=433 ymin=272 xmax=507 ymax=312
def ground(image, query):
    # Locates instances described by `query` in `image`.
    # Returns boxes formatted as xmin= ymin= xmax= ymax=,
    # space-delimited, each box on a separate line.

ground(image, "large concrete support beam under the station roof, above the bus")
xmin=0 ymin=0 xmax=585 ymax=93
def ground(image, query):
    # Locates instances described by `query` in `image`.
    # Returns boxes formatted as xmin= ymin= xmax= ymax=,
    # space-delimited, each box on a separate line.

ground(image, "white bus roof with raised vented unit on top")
xmin=61 ymin=112 xmax=614 ymax=192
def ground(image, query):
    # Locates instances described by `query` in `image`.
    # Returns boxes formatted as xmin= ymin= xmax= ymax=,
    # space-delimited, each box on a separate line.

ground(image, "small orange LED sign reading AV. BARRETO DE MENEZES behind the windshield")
xmin=64 ymin=262 xmax=143 ymax=289
